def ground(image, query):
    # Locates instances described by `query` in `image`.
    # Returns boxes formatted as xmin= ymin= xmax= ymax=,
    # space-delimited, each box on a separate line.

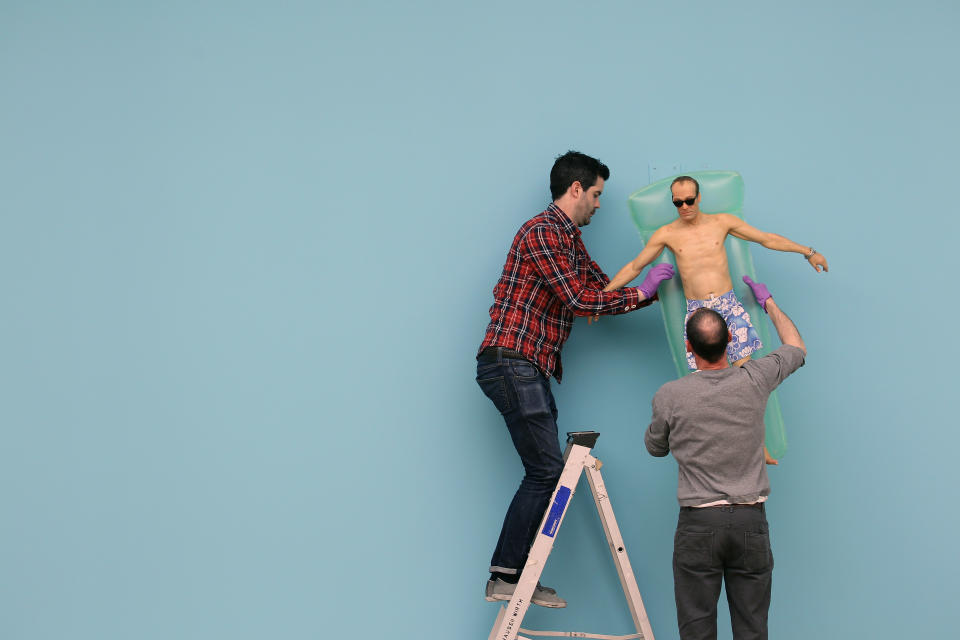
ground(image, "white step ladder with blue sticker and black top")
xmin=488 ymin=431 xmax=654 ymax=640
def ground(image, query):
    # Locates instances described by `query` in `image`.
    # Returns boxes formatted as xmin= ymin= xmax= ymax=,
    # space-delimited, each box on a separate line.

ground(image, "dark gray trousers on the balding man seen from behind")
xmin=673 ymin=505 xmax=773 ymax=640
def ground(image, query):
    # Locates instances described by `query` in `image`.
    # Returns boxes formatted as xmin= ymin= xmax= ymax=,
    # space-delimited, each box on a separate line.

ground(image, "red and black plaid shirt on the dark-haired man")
xmin=478 ymin=203 xmax=652 ymax=382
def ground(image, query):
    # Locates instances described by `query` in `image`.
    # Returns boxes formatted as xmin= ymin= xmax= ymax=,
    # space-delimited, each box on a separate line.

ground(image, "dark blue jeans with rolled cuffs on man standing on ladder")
xmin=477 ymin=351 xmax=563 ymax=574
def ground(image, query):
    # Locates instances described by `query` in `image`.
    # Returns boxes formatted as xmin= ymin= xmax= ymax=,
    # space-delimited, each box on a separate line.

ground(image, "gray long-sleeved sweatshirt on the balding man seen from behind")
xmin=644 ymin=345 xmax=804 ymax=506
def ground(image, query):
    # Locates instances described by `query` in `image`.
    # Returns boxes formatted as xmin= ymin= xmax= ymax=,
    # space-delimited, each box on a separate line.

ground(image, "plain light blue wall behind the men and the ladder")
xmin=0 ymin=0 xmax=960 ymax=640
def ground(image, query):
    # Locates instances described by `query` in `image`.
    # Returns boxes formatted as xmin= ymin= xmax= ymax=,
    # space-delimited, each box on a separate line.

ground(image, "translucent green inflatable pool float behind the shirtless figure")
xmin=627 ymin=171 xmax=787 ymax=458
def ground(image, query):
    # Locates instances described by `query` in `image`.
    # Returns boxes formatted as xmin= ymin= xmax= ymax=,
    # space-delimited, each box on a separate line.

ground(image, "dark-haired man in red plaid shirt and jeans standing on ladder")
xmin=477 ymin=151 xmax=673 ymax=607
